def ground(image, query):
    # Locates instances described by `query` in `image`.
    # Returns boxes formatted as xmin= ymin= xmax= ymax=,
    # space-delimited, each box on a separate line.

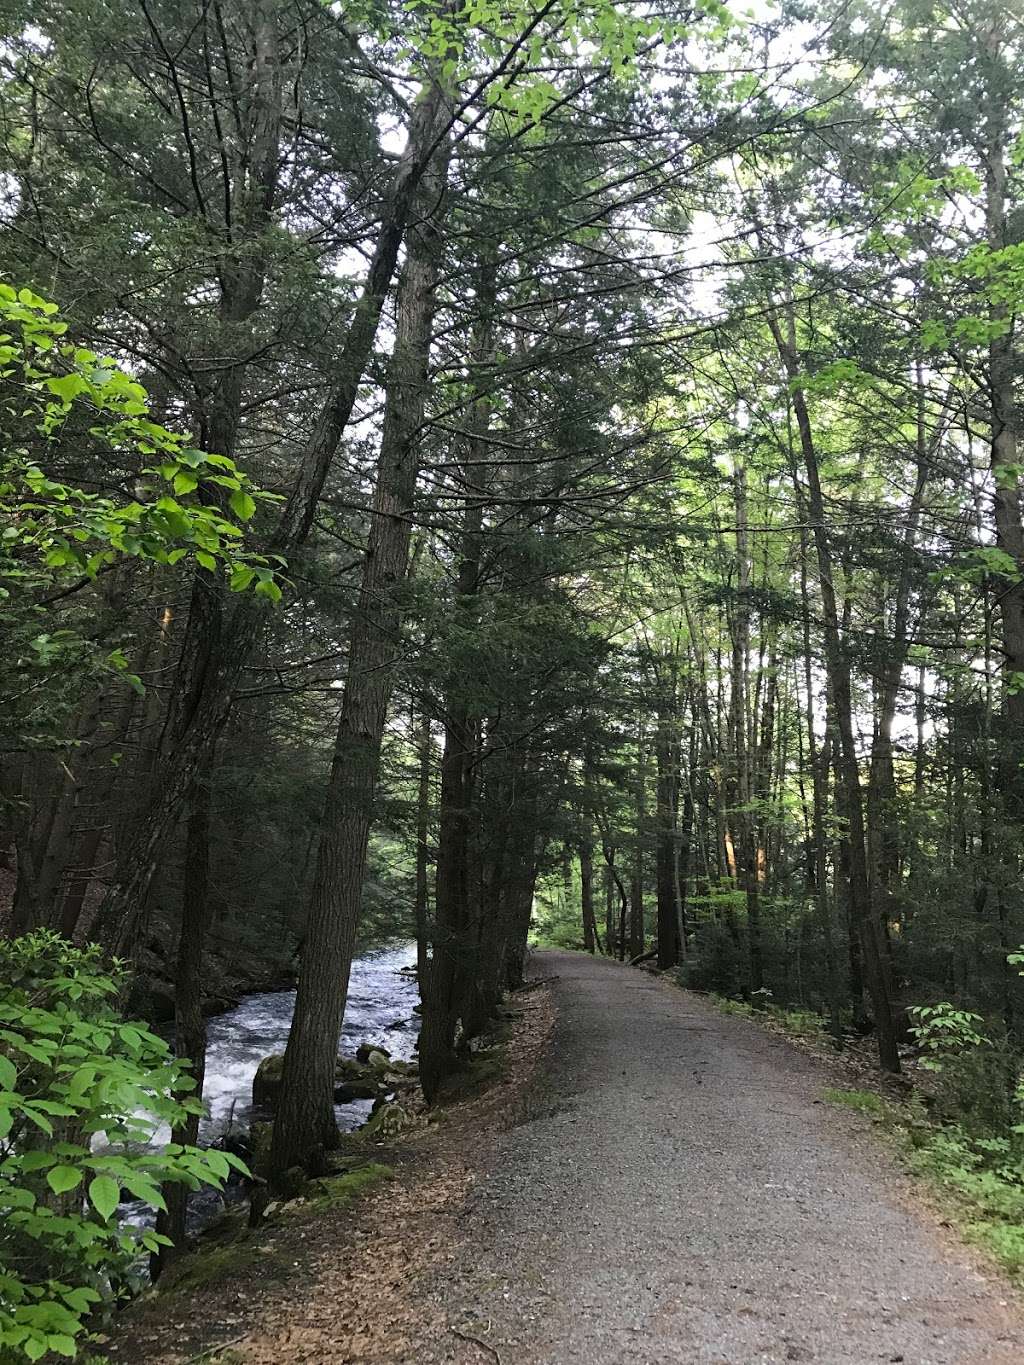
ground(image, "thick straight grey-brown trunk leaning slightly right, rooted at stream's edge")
xmin=270 ymin=146 xmax=448 ymax=1181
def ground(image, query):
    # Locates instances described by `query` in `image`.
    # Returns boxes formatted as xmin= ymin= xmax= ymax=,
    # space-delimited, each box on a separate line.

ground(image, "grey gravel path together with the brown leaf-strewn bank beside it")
xmin=112 ymin=951 xmax=1024 ymax=1365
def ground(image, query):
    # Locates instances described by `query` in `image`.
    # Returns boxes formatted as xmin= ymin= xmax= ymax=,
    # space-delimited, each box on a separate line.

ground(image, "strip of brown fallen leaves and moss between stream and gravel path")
xmin=104 ymin=990 xmax=553 ymax=1365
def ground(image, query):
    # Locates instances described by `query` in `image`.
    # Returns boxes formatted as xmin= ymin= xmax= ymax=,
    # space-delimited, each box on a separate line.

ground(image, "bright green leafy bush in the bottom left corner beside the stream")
xmin=0 ymin=931 xmax=244 ymax=1361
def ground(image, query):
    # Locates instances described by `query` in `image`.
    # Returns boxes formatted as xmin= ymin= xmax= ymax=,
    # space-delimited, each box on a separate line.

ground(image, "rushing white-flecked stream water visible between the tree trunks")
xmin=122 ymin=943 xmax=419 ymax=1231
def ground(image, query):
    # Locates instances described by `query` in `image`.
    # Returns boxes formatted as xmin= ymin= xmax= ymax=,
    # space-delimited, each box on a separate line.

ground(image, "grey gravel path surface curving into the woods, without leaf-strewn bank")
xmin=416 ymin=951 xmax=1024 ymax=1365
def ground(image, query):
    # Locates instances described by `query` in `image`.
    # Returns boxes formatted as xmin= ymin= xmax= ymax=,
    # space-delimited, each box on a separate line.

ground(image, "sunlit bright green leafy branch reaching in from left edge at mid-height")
xmin=0 ymin=283 xmax=280 ymax=599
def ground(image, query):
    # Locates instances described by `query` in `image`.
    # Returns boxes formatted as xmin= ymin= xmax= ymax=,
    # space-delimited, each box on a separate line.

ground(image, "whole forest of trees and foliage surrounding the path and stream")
xmin=0 ymin=0 xmax=1024 ymax=1361
